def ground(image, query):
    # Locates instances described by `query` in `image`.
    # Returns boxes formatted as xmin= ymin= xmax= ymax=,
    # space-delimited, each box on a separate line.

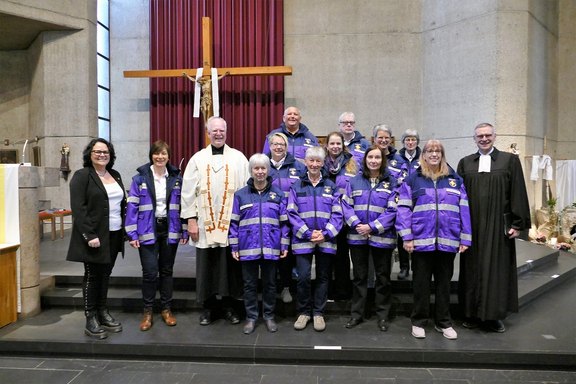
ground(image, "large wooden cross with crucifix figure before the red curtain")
xmin=124 ymin=17 xmax=292 ymax=125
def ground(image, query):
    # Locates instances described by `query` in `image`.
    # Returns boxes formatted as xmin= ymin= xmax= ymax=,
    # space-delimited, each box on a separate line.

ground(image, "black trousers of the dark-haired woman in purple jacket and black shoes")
xmin=350 ymin=244 xmax=392 ymax=320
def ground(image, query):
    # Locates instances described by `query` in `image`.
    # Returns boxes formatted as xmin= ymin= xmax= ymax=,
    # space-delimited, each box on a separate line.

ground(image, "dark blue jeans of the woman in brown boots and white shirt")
xmin=139 ymin=222 xmax=178 ymax=309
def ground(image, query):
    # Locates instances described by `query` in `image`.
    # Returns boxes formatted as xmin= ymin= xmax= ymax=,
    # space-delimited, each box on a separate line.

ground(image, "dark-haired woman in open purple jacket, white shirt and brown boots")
xmin=125 ymin=140 xmax=188 ymax=331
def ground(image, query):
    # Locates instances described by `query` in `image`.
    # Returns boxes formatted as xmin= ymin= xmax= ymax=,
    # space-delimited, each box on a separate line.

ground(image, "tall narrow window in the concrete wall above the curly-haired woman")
xmin=96 ymin=0 xmax=110 ymax=140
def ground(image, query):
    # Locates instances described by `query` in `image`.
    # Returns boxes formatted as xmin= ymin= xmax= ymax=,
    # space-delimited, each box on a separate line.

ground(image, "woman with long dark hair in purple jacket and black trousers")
xmin=342 ymin=146 xmax=398 ymax=331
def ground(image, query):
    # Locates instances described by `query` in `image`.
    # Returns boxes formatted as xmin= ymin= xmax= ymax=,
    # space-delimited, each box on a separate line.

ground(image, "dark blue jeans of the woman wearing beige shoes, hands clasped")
xmin=296 ymin=251 xmax=333 ymax=316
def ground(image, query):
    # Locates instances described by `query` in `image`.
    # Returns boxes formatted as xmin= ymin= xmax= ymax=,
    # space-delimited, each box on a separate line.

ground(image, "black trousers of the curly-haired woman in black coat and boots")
xmin=82 ymin=230 xmax=124 ymax=314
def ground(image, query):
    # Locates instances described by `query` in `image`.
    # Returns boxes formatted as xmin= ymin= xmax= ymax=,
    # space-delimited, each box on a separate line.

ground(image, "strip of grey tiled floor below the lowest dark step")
xmin=0 ymin=358 xmax=576 ymax=384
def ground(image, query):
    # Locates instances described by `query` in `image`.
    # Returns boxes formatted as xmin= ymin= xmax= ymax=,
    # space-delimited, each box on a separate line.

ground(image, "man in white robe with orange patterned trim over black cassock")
xmin=181 ymin=117 xmax=250 ymax=325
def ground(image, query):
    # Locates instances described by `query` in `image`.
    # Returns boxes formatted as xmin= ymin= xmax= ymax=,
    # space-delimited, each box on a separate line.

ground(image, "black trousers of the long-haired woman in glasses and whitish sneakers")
xmin=411 ymin=251 xmax=456 ymax=328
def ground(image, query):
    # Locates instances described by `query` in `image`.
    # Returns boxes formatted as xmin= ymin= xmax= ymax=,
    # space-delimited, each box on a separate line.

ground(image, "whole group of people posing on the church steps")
xmin=68 ymin=107 xmax=530 ymax=339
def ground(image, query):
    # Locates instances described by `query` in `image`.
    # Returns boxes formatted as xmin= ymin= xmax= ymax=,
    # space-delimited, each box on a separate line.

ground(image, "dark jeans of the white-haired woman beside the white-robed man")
xmin=241 ymin=259 xmax=277 ymax=321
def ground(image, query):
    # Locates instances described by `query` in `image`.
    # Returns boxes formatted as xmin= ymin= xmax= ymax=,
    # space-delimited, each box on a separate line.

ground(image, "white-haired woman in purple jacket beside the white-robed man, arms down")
xmin=228 ymin=153 xmax=290 ymax=335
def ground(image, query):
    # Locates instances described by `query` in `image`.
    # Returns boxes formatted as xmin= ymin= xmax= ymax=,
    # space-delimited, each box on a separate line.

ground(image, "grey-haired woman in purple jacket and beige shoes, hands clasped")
xmin=288 ymin=147 xmax=342 ymax=332
